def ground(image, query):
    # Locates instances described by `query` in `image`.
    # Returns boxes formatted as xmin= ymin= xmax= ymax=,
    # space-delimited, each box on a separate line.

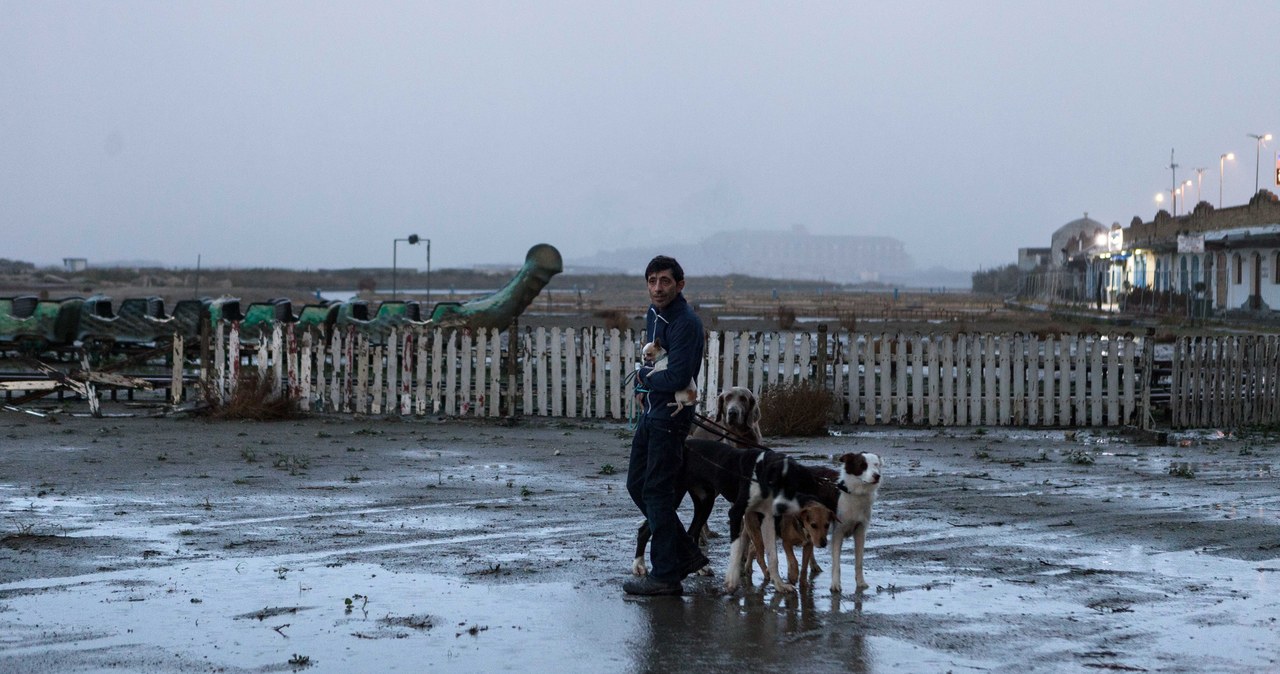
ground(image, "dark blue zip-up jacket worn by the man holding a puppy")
xmin=644 ymin=293 xmax=707 ymax=417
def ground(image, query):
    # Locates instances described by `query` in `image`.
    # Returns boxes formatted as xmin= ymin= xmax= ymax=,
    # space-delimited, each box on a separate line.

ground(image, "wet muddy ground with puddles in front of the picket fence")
xmin=0 ymin=405 xmax=1280 ymax=673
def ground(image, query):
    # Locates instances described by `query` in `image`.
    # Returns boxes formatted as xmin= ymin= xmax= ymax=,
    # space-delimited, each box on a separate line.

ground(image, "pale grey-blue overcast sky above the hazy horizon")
xmin=0 ymin=0 xmax=1280 ymax=274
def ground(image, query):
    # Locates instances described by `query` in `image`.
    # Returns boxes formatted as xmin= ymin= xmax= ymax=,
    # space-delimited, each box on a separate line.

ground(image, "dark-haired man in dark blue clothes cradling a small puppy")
xmin=622 ymin=256 xmax=707 ymax=595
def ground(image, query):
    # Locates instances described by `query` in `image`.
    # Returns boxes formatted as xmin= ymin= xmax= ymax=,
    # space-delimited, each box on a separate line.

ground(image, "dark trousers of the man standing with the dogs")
xmin=627 ymin=408 xmax=701 ymax=583
